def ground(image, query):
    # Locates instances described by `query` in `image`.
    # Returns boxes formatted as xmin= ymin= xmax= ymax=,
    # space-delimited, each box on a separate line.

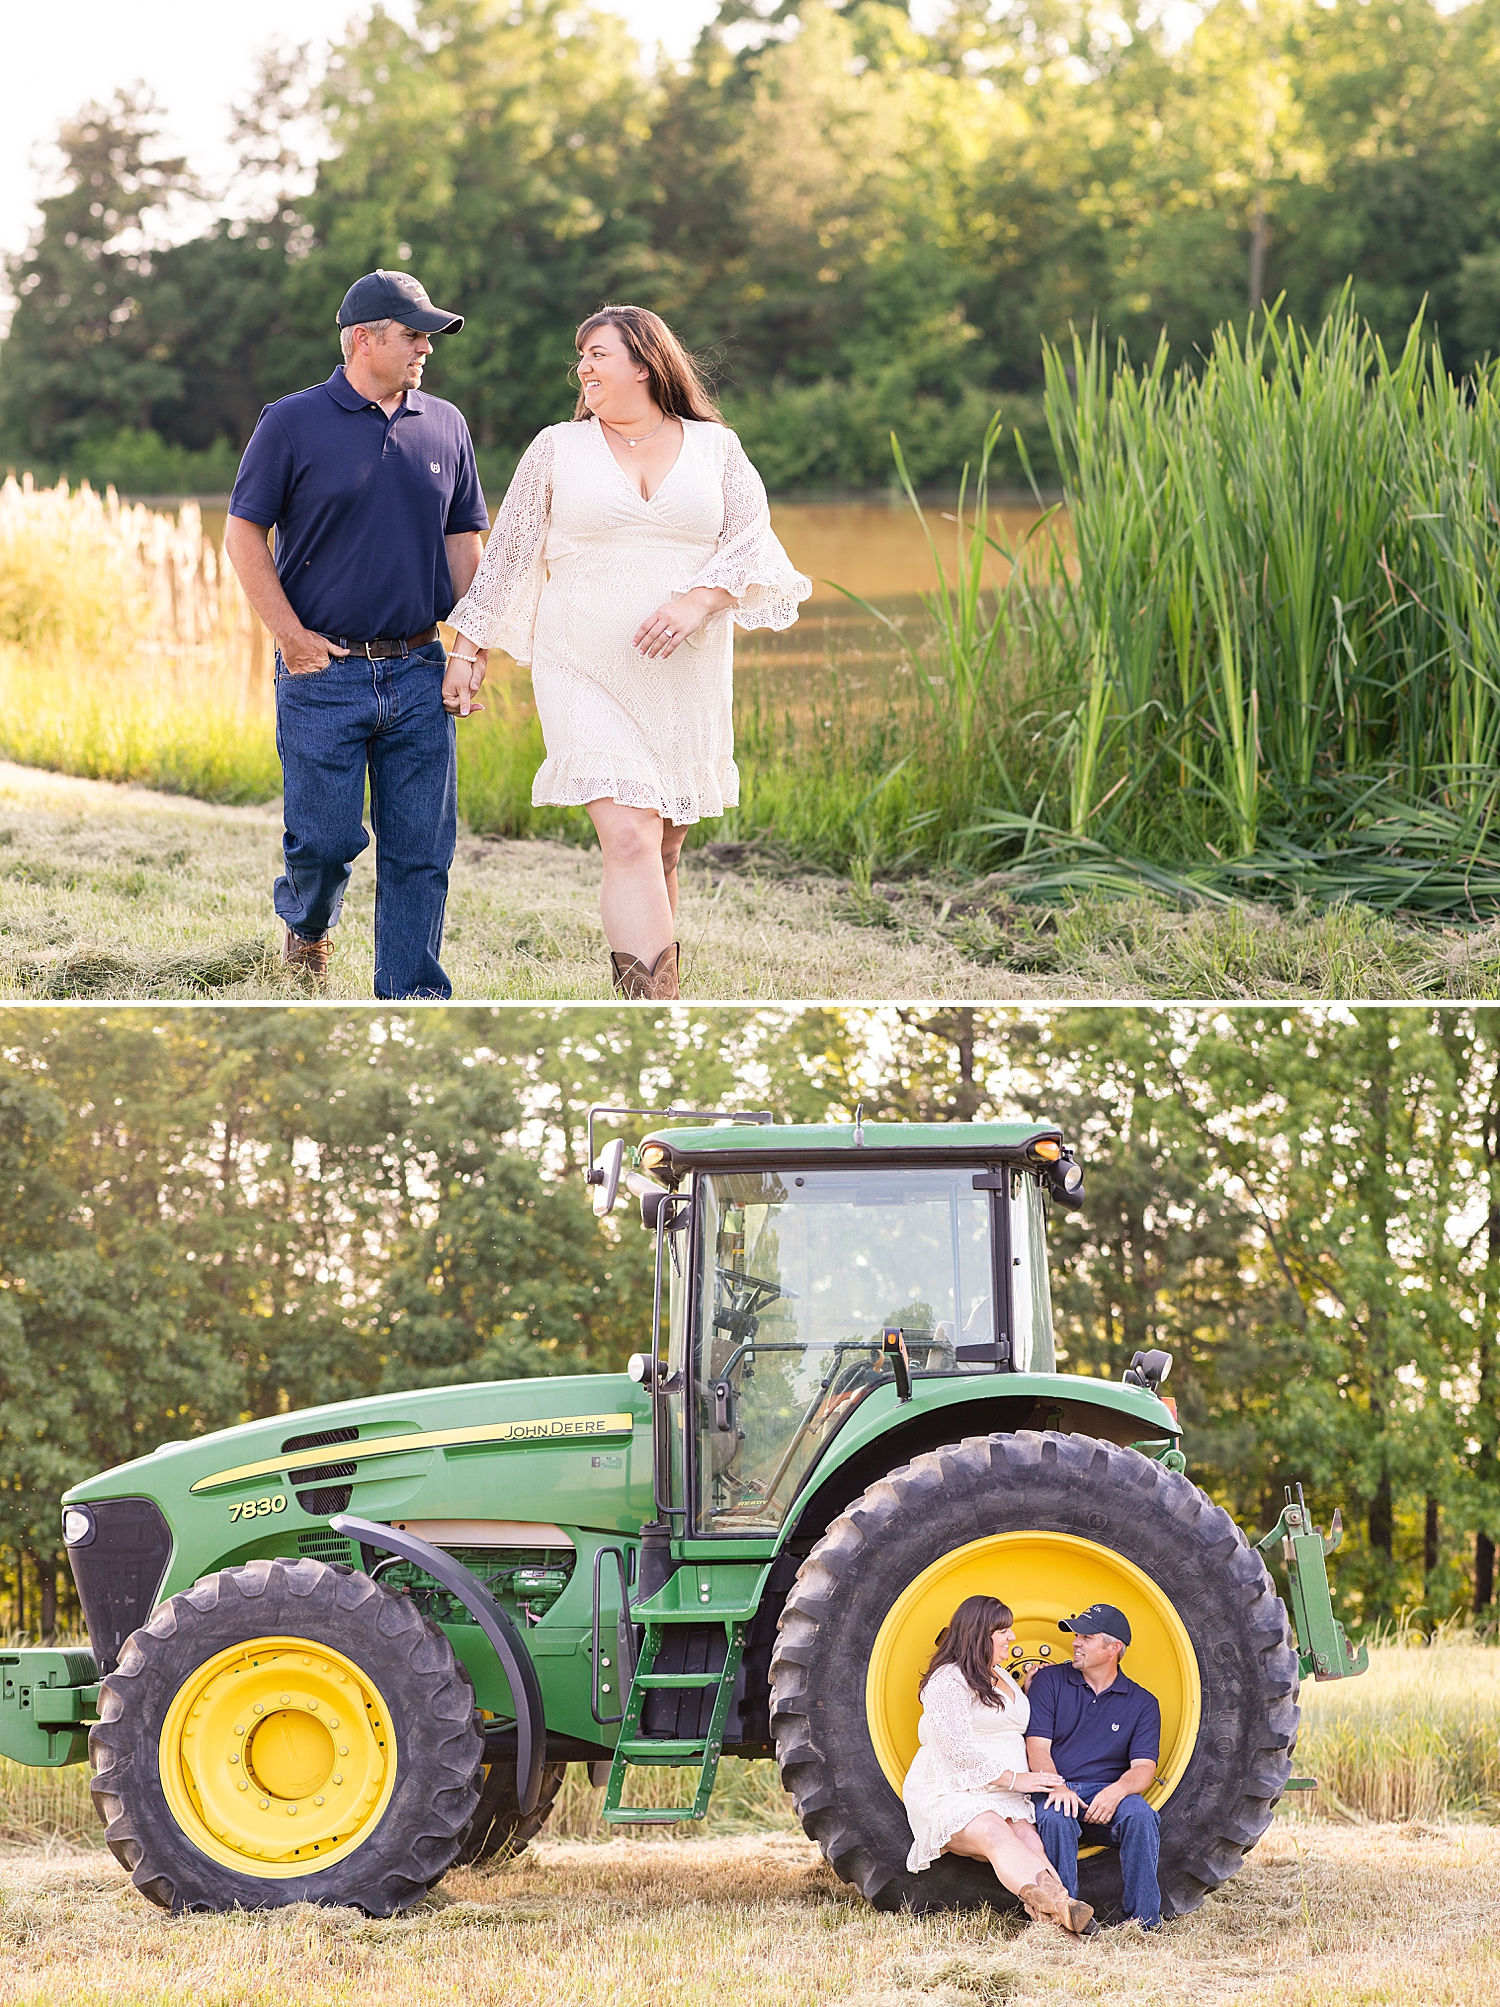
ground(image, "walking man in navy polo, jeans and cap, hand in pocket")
xmin=225 ymin=271 xmax=490 ymax=997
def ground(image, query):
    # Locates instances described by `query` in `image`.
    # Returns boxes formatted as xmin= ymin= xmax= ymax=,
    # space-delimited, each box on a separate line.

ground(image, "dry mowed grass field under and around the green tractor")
xmin=0 ymin=1636 xmax=1500 ymax=2007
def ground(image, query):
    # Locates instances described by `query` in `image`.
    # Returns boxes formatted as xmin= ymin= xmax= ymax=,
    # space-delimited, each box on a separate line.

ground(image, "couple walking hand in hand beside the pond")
xmin=225 ymin=271 xmax=811 ymax=999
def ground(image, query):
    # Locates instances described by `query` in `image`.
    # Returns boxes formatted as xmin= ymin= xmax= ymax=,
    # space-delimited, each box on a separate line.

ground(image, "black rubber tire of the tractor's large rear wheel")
xmin=771 ymin=1431 xmax=1297 ymax=1921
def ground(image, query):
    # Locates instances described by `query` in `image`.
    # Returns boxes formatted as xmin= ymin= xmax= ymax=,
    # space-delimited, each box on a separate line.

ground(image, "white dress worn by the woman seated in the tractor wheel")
xmin=902 ymin=1666 xmax=1036 ymax=1875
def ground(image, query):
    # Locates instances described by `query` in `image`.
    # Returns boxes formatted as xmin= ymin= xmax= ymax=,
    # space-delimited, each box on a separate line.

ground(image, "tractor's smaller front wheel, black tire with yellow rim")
xmin=88 ymin=1559 xmax=484 ymax=1917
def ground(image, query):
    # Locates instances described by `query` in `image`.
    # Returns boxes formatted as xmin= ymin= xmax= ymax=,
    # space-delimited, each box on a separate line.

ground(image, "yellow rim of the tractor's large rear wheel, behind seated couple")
xmin=865 ymin=1533 xmax=1203 ymax=1806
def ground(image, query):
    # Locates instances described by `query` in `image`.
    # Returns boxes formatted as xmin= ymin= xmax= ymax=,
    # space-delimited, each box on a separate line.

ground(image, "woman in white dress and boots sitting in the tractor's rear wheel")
xmin=902 ymin=1596 xmax=1094 ymax=1933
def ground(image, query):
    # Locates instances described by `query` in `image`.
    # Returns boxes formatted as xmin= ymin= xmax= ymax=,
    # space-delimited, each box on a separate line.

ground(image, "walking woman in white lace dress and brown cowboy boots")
xmin=448 ymin=307 xmax=813 ymax=997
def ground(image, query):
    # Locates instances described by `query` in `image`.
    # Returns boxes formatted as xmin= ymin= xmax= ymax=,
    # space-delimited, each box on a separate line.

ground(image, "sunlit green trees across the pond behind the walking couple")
xmin=0 ymin=0 xmax=1500 ymax=492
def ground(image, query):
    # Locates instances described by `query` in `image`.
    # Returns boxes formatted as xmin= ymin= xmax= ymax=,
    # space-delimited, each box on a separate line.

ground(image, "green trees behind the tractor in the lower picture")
xmin=0 ymin=1008 xmax=1500 ymax=1632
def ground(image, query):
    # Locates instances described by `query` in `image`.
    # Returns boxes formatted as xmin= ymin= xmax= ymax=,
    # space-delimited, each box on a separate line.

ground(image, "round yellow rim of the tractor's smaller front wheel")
xmin=159 ymin=1638 xmax=396 ymax=1881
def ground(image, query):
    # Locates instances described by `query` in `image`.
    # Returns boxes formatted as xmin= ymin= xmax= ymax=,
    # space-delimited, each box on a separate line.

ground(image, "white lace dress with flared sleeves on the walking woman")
xmin=448 ymin=417 xmax=813 ymax=823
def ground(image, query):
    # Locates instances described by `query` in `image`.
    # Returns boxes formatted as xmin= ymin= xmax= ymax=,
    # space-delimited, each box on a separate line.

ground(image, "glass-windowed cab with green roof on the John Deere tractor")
xmin=600 ymin=1110 xmax=1100 ymax=1537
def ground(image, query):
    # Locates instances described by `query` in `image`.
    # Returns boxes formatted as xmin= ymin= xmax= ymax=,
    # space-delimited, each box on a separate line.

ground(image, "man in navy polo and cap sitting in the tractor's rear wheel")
xmin=1026 ymin=1604 xmax=1161 ymax=1931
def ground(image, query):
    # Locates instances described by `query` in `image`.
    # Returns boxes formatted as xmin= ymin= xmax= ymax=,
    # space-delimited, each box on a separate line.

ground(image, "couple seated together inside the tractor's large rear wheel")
xmin=902 ymin=1596 xmax=1161 ymax=1937
